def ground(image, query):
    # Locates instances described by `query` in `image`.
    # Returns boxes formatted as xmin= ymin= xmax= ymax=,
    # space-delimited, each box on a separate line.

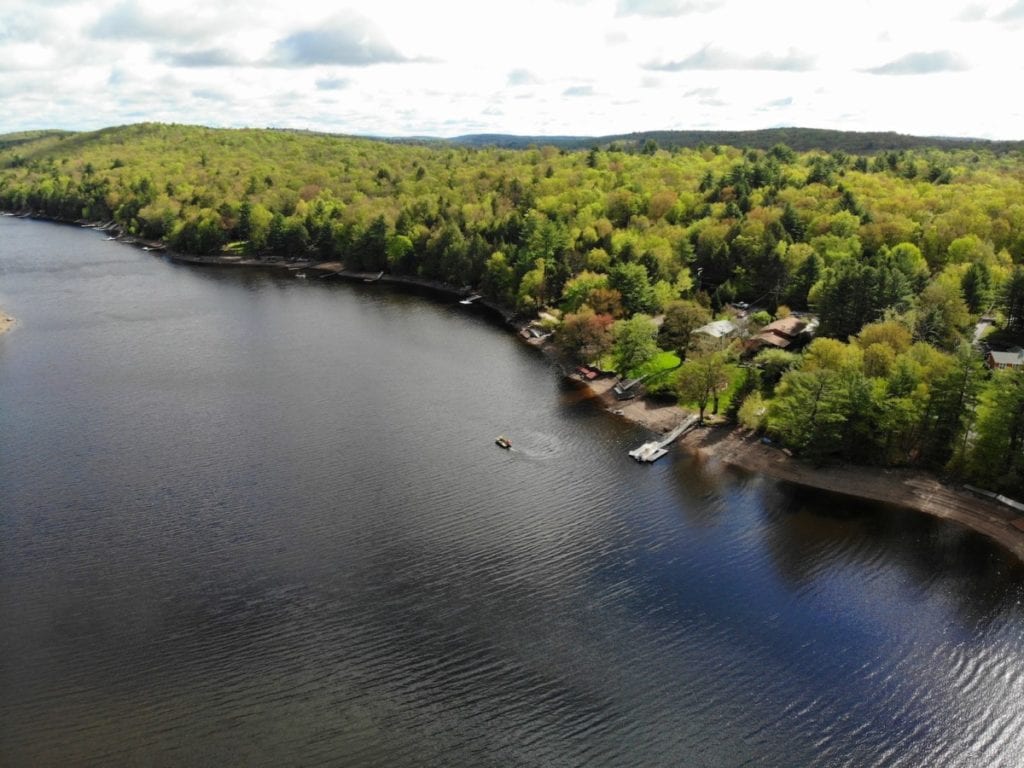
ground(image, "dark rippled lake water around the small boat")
xmin=0 ymin=218 xmax=1024 ymax=767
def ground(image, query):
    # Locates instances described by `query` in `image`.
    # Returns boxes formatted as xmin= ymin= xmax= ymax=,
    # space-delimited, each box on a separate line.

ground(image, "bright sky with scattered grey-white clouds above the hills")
xmin=0 ymin=0 xmax=1024 ymax=139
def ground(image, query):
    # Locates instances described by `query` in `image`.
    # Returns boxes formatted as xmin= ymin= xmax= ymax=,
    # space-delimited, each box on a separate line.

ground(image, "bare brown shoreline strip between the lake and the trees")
xmin=8 ymin=214 xmax=1024 ymax=563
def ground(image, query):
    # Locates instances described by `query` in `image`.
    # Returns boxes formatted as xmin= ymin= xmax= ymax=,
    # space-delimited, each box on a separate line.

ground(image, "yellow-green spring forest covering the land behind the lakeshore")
xmin=6 ymin=124 xmax=1024 ymax=493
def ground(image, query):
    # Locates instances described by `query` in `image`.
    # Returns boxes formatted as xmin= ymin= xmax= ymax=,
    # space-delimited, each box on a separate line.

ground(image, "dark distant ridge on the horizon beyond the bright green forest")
xmin=449 ymin=128 xmax=1024 ymax=155
